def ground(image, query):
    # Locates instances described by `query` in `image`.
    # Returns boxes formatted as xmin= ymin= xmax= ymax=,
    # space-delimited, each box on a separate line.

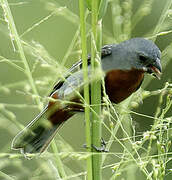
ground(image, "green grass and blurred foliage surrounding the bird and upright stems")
xmin=0 ymin=0 xmax=172 ymax=180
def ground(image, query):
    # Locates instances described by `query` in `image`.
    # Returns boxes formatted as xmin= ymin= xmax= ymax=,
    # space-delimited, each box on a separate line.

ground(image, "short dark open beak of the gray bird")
xmin=148 ymin=58 xmax=162 ymax=79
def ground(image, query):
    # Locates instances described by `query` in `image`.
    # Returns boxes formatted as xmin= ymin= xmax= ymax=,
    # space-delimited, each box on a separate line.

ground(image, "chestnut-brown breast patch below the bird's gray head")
xmin=105 ymin=69 xmax=144 ymax=104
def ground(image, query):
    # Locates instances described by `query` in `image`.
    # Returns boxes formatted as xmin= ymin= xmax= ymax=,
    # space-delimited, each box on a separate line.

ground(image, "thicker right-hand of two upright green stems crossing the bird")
xmin=91 ymin=0 xmax=102 ymax=180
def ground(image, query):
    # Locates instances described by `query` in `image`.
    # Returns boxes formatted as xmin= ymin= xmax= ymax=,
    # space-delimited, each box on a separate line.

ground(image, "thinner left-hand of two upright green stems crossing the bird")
xmin=79 ymin=0 xmax=92 ymax=180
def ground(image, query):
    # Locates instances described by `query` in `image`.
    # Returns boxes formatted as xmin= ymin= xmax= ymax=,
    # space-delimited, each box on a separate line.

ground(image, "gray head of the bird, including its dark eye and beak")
xmin=116 ymin=38 xmax=162 ymax=78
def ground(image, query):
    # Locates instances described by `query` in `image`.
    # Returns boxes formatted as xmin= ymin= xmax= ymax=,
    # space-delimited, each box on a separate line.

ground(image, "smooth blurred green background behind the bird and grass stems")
xmin=0 ymin=0 xmax=172 ymax=180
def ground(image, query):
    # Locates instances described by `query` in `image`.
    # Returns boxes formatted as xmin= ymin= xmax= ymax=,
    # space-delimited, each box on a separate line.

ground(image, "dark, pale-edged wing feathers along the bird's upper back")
xmin=50 ymin=44 xmax=113 ymax=96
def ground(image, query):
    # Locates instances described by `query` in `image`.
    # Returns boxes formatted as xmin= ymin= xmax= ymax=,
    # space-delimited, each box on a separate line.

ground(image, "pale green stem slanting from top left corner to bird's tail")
xmin=1 ymin=0 xmax=42 ymax=109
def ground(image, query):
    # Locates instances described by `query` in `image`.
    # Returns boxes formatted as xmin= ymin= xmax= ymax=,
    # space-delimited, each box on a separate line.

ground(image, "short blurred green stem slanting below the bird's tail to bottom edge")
xmin=51 ymin=140 xmax=67 ymax=179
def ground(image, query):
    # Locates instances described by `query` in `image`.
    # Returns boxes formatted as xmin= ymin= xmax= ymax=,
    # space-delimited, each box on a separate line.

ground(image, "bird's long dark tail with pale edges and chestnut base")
xmin=12 ymin=106 xmax=73 ymax=154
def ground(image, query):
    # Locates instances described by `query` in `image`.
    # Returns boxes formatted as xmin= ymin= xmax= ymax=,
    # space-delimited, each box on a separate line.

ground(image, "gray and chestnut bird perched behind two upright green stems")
xmin=12 ymin=37 xmax=162 ymax=154
